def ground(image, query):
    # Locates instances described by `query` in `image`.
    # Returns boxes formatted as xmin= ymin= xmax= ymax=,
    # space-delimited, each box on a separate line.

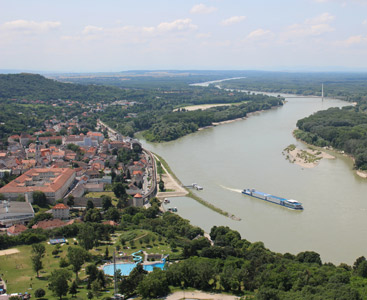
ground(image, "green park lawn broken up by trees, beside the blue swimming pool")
xmin=0 ymin=229 xmax=172 ymax=300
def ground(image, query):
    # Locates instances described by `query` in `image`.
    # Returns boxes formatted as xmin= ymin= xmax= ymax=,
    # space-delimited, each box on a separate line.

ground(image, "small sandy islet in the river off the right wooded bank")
xmin=283 ymin=145 xmax=335 ymax=168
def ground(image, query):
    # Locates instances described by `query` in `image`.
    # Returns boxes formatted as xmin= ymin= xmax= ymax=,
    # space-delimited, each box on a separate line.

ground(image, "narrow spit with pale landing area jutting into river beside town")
xmin=154 ymin=153 xmax=241 ymax=221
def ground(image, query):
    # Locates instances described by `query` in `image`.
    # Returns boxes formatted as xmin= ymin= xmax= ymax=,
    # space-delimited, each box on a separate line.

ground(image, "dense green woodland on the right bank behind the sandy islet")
xmin=295 ymin=106 xmax=367 ymax=170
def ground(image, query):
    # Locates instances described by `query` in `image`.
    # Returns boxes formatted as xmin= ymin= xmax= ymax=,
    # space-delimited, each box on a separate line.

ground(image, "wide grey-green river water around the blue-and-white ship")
xmin=142 ymin=88 xmax=367 ymax=264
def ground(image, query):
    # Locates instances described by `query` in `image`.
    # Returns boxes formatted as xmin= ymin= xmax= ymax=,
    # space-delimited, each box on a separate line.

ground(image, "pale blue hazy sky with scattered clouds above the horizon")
xmin=0 ymin=0 xmax=367 ymax=72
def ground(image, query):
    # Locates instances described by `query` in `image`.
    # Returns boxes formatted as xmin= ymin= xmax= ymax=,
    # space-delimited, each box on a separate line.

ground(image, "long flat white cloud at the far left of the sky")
xmin=1 ymin=20 xmax=61 ymax=33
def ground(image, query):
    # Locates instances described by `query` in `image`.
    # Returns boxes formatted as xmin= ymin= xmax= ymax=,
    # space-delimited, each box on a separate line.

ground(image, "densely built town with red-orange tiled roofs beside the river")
xmin=0 ymin=118 xmax=157 ymax=235
